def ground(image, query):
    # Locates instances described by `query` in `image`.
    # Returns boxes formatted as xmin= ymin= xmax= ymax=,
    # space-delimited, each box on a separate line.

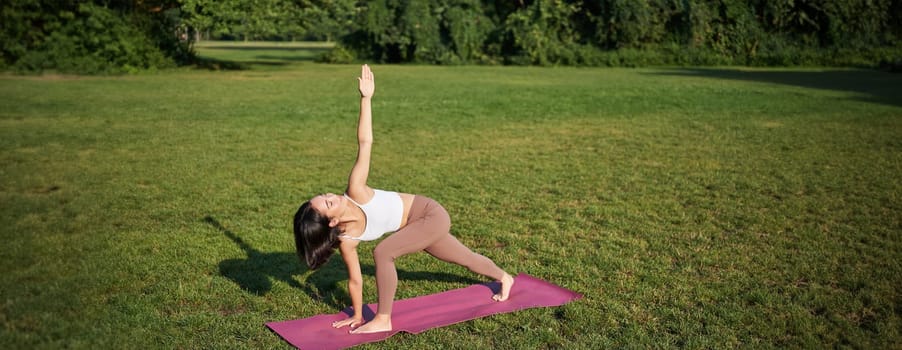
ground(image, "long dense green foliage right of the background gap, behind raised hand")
xmin=344 ymin=0 xmax=902 ymax=65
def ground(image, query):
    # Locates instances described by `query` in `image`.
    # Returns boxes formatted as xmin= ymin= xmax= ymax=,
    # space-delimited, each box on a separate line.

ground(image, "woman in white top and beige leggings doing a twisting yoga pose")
xmin=294 ymin=65 xmax=514 ymax=333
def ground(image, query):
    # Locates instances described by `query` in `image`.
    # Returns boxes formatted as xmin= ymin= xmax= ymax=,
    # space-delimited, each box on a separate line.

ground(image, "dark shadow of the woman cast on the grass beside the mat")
xmin=203 ymin=216 xmax=482 ymax=309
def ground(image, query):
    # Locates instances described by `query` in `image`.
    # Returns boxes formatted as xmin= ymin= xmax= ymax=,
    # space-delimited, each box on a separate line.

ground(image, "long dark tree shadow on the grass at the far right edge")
xmin=650 ymin=68 xmax=902 ymax=107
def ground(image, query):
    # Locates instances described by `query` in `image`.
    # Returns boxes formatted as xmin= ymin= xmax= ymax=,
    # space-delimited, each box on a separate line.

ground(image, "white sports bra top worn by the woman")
xmin=342 ymin=189 xmax=404 ymax=241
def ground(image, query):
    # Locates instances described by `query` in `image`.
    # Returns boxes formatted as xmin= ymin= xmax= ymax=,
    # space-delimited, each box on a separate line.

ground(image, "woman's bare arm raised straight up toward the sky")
xmin=347 ymin=65 xmax=376 ymax=203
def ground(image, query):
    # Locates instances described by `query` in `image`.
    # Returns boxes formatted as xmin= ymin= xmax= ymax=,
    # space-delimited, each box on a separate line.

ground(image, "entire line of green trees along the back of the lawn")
xmin=0 ymin=0 xmax=902 ymax=72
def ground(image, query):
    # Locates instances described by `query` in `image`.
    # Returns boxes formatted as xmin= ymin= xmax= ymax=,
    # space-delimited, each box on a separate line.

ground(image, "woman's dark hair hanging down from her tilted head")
xmin=294 ymin=201 xmax=341 ymax=270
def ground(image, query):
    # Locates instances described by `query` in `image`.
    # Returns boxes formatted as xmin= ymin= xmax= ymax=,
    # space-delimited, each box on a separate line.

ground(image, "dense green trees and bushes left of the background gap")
xmin=0 ymin=0 xmax=190 ymax=73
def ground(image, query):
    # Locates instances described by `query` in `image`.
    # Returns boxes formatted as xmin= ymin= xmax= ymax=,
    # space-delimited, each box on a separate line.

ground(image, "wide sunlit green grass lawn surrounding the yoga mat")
xmin=0 ymin=43 xmax=902 ymax=349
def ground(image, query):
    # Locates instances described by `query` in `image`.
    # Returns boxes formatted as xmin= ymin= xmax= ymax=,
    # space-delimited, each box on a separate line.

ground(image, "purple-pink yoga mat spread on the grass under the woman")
xmin=266 ymin=273 xmax=582 ymax=349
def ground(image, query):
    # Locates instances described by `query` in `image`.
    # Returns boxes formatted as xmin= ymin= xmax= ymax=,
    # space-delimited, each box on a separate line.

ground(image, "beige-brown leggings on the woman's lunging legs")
xmin=373 ymin=196 xmax=504 ymax=315
